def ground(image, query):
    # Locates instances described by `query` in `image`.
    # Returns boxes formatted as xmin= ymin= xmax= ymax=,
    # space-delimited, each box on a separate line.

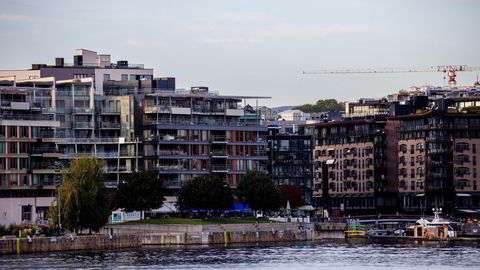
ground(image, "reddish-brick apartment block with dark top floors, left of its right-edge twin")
xmin=304 ymin=119 xmax=396 ymax=215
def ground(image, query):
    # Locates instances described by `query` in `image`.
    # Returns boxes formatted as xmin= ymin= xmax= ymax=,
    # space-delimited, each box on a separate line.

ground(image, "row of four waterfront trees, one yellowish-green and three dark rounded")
xmin=49 ymin=158 xmax=288 ymax=231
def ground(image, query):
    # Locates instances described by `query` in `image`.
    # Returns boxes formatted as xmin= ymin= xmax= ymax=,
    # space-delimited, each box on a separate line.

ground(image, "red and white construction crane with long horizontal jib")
xmin=302 ymin=65 xmax=480 ymax=86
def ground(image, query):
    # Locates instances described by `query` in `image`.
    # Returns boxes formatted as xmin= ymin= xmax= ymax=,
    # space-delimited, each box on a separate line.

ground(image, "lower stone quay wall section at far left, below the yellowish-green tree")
xmin=0 ymin=234 xmax=142 ymax=255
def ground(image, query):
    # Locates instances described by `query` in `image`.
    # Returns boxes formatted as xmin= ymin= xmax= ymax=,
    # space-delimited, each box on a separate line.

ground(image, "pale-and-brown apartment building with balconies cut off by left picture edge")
xmin=0 ymin=86 xmax=61 ymax=224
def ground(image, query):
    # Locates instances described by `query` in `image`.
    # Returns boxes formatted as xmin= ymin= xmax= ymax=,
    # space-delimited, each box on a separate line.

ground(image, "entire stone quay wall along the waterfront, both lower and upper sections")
xmin=0 ymin=223 xmax=345 ymax=255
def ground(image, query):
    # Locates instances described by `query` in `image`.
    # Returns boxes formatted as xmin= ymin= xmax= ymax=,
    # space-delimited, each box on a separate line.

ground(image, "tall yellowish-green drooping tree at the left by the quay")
xmin=51 ymin=158 xmax=110 ymax=231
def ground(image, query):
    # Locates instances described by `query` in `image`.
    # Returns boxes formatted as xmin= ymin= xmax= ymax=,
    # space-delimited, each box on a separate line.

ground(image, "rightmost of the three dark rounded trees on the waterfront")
xmin=237 ymin=171 xmax=280 ymax=211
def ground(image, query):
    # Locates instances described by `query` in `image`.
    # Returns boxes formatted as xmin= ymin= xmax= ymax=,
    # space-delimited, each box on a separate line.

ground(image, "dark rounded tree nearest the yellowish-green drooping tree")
xmin=116 ymin=171 xmax=165 ymax=215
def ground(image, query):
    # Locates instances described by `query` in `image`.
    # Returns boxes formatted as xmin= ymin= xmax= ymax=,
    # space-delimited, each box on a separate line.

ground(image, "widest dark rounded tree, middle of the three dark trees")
xmin=177 ymin=175 xmax=233 ymax=211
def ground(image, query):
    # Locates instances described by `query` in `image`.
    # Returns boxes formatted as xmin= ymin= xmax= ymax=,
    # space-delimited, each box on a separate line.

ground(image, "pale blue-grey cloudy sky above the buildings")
xmin=0 ymin=0 xmax=480 ymax=106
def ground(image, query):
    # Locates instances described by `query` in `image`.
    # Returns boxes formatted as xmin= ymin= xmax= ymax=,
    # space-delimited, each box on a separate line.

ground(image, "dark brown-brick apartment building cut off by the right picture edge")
xmin=387 ymin=110 xmax=480 ymax=213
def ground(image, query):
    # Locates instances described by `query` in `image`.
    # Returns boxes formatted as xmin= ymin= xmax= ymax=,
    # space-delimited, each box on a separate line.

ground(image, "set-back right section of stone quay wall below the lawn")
xmin=105 ymin=223 xmax=345 ymax=245
